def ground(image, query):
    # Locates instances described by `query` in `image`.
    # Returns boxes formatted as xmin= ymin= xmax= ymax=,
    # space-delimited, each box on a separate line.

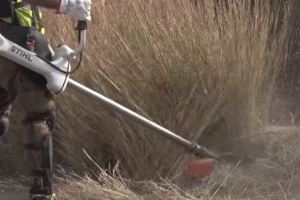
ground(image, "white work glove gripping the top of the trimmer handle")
xmin=59 ymin=0 xmax=92 ymax=21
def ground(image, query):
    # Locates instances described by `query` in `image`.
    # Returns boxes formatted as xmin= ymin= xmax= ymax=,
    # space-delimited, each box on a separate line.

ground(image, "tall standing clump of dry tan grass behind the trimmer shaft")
xmin=44 ymin=0 xmax=286 ymax=179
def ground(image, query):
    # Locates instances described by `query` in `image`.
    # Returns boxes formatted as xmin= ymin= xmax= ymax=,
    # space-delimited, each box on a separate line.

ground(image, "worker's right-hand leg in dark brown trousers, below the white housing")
xmin=18 ymin=70 xmax=55 ymax=199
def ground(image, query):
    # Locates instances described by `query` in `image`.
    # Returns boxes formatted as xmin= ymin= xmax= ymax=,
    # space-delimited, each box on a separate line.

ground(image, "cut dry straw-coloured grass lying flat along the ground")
xmin=58 ymin=128 xmax=300 ymax=200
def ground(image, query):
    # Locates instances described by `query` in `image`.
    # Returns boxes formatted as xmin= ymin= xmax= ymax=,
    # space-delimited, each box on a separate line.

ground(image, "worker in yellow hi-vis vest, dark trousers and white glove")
xmin=0 ymin=0 xmax=91 ymax=200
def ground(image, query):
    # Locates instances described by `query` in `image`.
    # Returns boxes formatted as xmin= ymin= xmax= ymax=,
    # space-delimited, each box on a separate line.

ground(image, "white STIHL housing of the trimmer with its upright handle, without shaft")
xmin=0 ymin=22 xmax=86 ymax=93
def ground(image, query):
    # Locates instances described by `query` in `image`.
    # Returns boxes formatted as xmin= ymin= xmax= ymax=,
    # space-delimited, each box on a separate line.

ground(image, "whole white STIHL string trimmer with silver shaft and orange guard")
xmin=0 ymin=21 xmax=219 ymax=176
